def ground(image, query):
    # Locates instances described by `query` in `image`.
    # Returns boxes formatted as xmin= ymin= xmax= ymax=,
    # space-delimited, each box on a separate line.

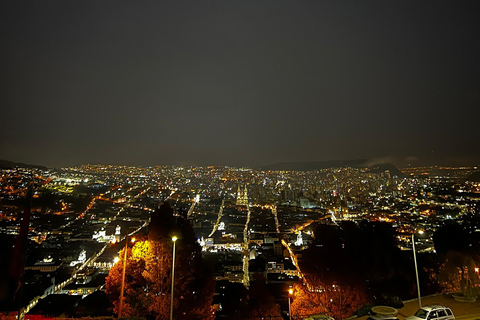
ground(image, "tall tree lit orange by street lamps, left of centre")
xmin=106 ymin=203 xmax=214 ymax=320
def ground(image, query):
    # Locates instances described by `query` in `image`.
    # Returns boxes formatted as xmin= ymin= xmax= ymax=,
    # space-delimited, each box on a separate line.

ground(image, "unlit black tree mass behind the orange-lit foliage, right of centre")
xmin=300 ymin=221 xmax=415 ymax=299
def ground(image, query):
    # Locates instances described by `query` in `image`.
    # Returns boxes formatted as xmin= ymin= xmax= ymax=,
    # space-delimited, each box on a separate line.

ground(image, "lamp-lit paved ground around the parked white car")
xmin=398 ymin=295 xmax=480 ymax=320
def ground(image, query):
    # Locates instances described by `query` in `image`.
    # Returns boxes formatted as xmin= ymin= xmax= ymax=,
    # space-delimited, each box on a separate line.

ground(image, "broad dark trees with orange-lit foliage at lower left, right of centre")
xmin=293 ymin=221 xmax=415 ymax=319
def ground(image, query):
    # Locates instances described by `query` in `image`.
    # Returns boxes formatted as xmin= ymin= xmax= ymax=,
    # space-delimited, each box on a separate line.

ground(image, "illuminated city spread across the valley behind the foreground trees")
xmin=0 ymin=165 xmax=480 ymax=319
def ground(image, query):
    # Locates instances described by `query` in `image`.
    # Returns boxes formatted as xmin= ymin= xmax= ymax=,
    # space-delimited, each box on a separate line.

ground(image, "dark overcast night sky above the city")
xmin=0 ymin=0 xmax=480 ymax=166
